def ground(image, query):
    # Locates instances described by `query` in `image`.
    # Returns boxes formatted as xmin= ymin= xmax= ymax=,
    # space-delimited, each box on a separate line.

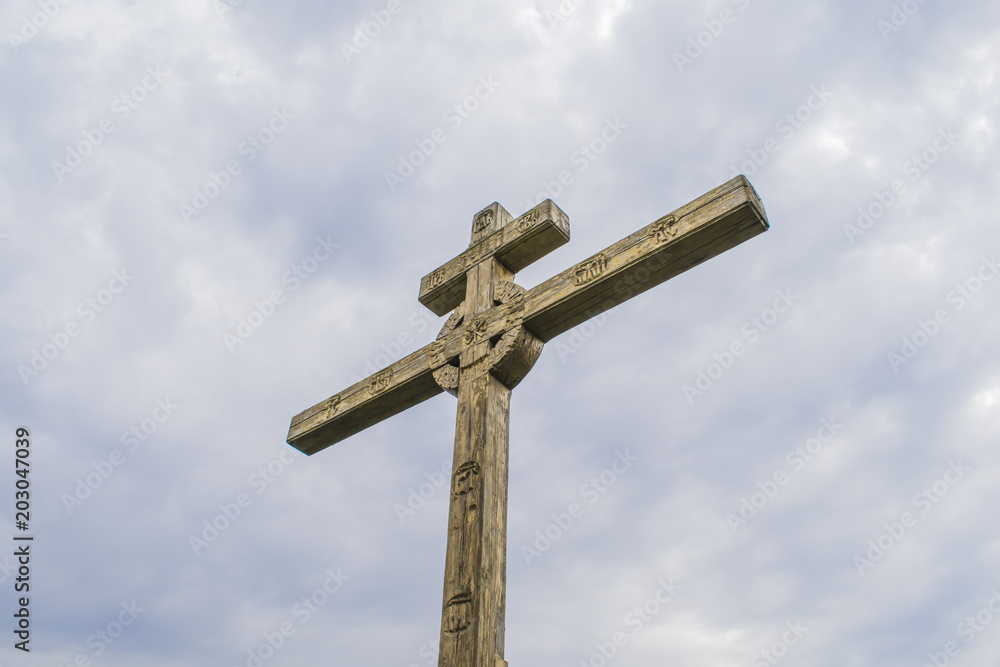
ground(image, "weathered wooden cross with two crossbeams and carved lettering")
xmin=288 ymin=176 xmax=768 ymax=667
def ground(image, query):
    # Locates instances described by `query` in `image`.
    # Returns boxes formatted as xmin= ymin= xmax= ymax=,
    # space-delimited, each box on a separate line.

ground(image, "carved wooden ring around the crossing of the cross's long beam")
xmin=431 ymin=281 xmax=544 ymax=395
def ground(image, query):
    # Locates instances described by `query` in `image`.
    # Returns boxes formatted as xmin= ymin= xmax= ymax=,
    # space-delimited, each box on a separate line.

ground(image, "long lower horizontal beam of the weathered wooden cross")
xmin=288 ymin=176 xmax=768 ymax=454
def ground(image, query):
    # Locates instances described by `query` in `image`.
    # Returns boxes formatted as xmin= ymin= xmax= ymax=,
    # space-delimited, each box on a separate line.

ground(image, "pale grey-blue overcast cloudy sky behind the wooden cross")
xmin=0 ymin=0 xmax=1000 ymax=667
